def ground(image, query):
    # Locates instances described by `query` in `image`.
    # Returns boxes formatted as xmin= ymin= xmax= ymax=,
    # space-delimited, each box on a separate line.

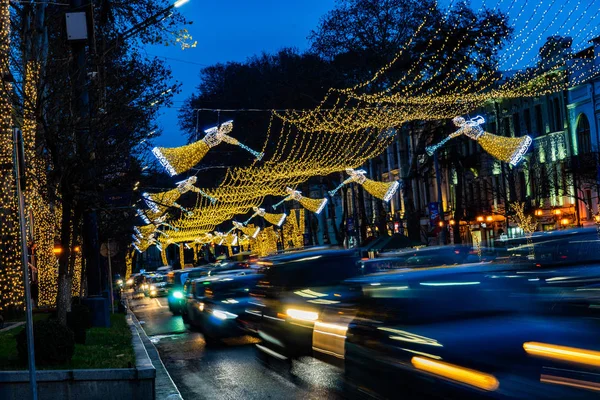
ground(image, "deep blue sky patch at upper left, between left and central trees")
xmin=147 ymin=0 xmax=334 ymax=147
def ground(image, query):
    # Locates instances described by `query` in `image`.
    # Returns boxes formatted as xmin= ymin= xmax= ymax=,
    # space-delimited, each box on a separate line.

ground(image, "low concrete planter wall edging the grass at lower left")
xmin=0 ymin=316 xmax=156 ymax=400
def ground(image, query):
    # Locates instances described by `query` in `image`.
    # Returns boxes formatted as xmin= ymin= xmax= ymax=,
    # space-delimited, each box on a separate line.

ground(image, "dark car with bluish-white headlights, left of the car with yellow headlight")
xmin=188 ymin=274 xmax=262 ymax=343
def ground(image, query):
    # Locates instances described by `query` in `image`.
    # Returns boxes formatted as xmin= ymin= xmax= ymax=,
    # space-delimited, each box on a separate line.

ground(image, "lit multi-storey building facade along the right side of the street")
xmin=364 ymin=38 xmax=600 ymax=245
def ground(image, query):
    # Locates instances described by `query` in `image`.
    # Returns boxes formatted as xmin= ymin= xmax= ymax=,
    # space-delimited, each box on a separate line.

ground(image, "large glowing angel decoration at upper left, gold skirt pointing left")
xmin=152 ymin=121 xmax=264 ymax=176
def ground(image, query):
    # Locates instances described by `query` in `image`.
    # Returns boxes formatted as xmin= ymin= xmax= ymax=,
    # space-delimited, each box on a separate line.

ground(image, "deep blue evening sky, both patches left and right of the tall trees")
xmin=147 ymin=0 xmax=600 ymax=147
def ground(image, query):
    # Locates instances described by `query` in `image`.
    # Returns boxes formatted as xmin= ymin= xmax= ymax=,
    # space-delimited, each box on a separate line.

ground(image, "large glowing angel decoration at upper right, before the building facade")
xmin=425 ymin=116 xmax=531 ymax=166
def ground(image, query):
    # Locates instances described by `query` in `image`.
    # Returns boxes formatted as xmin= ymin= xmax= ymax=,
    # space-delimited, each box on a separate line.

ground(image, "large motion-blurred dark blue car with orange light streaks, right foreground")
xmin=338 ymin=267 xmax=600 ymax=399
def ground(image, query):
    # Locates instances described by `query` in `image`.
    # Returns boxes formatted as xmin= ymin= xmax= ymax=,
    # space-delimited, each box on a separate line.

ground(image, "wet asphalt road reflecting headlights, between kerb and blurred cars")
xmin=130 ymin=298 xmax=344 ymax=400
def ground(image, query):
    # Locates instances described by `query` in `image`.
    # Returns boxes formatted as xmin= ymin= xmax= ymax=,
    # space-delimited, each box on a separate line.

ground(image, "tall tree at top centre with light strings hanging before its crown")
xmin=309 ymin=0 xmax=512 ymax=240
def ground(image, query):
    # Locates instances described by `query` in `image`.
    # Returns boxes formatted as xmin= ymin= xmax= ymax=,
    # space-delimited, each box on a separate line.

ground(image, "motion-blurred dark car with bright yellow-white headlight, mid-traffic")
xmin=240 ymin=250 xmax=359 ymax=359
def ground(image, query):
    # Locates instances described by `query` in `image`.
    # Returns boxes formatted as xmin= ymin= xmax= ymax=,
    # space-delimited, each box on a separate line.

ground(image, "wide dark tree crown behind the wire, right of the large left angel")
xmin=180 ymin=48 xmax=340 ymax=191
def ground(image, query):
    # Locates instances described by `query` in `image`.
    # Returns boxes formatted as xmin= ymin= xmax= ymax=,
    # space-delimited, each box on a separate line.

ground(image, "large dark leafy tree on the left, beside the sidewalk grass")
xmin=9 ymin=0 xmax=192 ymax=324
